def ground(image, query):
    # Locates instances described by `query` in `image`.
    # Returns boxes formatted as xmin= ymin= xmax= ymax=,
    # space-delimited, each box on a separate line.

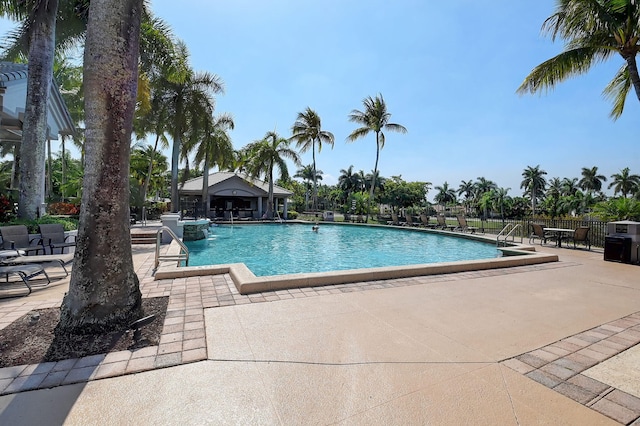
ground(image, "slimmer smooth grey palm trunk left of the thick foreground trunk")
xmin=18 ymin=0 xmax=58 ymax=219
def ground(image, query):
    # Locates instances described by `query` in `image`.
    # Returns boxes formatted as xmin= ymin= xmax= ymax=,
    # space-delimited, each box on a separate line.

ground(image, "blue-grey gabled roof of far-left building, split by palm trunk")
xmin=0 ymin=62 xmax=75 ymax=142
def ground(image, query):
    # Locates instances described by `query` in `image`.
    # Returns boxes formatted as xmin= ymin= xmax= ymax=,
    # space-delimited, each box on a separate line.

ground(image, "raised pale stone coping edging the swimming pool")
xmin=154 ymin=224 xmax=558 ymax=295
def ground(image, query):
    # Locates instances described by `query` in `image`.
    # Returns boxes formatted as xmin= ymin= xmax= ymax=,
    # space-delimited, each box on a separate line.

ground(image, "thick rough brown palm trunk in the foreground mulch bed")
xmin=56 ymin=0 xmax=143 ymax=334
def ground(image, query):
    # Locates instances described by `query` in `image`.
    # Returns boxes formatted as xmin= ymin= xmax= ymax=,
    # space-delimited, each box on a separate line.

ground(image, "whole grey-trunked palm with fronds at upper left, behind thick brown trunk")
xmin=0 ymin=0 xmax=174 ymax=218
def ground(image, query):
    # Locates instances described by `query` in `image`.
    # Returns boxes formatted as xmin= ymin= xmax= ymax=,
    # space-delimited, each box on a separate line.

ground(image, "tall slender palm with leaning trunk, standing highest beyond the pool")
xmin=347 ymin=94 xmax=407 ymax=223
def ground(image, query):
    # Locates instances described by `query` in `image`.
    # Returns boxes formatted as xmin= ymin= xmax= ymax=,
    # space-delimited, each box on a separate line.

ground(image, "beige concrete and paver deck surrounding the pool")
xmin=0 ymin=231 xmax=640 ymax=425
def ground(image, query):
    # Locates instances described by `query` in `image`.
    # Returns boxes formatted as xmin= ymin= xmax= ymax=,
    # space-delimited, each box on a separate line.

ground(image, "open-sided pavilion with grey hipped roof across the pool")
xmin=179 ymin=172 xmax=293 ymax=220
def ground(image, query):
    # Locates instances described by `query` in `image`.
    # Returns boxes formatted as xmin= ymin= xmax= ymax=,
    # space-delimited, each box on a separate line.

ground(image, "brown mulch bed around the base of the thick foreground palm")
xmin=0 ymin=297 xmax=169 ymax=367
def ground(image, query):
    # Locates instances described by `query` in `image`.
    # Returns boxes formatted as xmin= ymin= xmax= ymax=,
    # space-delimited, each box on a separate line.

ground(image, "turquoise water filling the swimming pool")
xmin=185 ymin=224 xmax=501 ymax=276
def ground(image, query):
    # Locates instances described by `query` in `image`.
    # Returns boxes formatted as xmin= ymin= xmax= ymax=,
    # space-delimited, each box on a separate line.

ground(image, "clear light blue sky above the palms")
xmin=0 ymin=0 xmax=640 ymax=199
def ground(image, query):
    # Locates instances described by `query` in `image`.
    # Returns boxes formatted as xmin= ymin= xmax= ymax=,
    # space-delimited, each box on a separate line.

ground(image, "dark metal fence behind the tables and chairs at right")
xmin=462 ymin=218 xmax=607 ymax=247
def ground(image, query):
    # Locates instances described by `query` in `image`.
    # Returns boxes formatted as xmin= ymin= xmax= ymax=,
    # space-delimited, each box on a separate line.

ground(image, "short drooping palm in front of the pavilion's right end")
xmin=246 ymin=132 xmax=300 ymax=219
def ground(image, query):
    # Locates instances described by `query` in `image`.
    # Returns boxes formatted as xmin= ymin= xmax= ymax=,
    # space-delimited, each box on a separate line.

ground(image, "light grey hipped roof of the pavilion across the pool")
xmin=180 ymin=172 xmax=293 ymax=197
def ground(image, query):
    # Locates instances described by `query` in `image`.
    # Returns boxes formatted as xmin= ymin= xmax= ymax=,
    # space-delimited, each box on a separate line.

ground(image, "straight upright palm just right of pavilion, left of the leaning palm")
xmin=291 ymin=107 xmax=335 ymax=211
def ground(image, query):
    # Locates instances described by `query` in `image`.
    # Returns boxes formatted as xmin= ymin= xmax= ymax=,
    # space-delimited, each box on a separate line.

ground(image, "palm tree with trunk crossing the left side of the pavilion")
xmin=194 ymin=114 xmax=235 ymax=215
